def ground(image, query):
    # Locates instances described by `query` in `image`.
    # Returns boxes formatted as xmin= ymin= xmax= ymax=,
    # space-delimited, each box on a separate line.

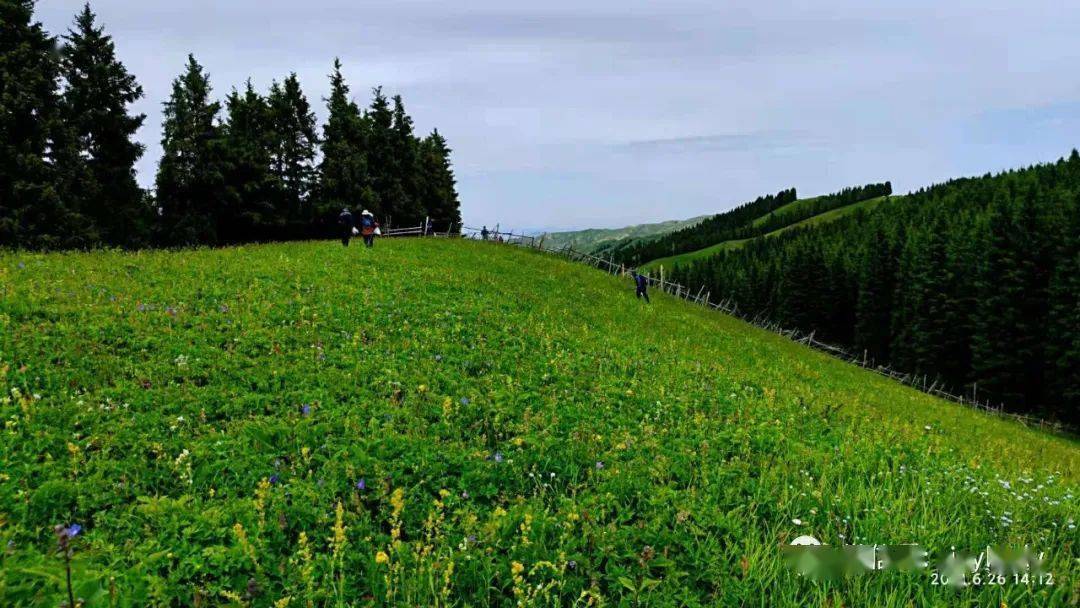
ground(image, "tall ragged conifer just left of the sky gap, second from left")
xmin=62 ymin=4 xmax=152 ymax=246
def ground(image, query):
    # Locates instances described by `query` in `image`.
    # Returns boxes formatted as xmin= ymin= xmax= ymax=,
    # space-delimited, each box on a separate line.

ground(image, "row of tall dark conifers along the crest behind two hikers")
xmin=0 ymin=0 xmax=461 ymax=249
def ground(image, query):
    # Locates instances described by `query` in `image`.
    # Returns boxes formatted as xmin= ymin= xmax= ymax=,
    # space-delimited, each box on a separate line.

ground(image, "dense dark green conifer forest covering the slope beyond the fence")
xmin=673 ymin=151 xmax=1080 ymax=424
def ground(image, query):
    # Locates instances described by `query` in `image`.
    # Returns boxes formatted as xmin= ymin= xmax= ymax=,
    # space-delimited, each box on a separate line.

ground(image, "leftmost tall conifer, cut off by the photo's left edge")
xmin=0 ymin=0 xmax=90 ymax=248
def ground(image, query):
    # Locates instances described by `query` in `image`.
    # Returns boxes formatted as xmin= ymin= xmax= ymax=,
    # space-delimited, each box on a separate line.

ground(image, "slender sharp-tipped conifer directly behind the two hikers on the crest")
xmin=316 ymin=59 xmax=375 ymax=224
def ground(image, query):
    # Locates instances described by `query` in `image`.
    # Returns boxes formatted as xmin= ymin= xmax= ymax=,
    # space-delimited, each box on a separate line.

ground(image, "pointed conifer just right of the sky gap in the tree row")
xmin=157 ymin=55 xmax=228 ymax=245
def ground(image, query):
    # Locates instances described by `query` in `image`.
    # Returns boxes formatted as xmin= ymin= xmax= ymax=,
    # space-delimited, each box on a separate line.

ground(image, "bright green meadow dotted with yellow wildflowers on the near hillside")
xmin=0 ymin=240 xmax=1080 ymax=607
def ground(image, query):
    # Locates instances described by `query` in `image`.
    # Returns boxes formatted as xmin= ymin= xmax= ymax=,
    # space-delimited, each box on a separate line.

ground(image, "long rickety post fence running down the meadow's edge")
xmin=395 ymin=225 xmax=1078 ymax=436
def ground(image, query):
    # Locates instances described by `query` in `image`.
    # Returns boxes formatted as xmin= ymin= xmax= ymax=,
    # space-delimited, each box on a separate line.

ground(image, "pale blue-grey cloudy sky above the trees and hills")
xmin=37 ymin=0 xmax=1080 ymax=230
